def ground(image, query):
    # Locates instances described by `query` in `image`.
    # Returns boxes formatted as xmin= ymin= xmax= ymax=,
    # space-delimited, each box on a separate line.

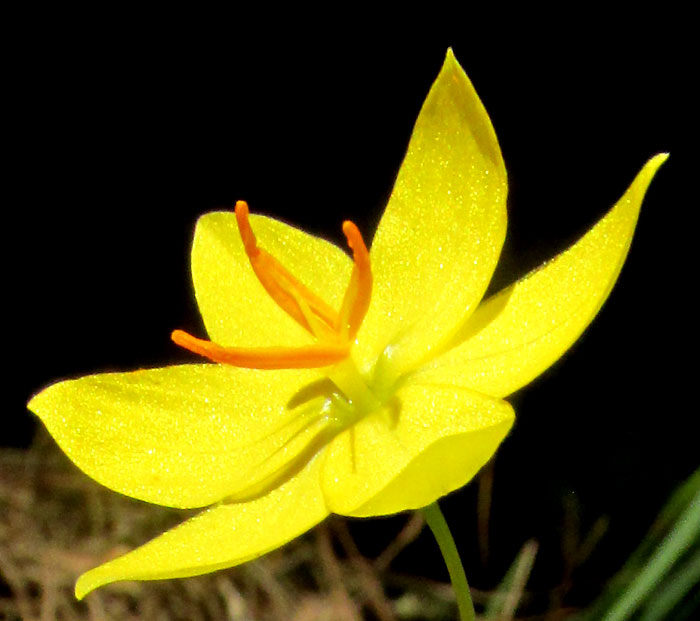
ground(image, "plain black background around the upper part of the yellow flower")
xmin=8 ymin=13 xmax=698 ymax=604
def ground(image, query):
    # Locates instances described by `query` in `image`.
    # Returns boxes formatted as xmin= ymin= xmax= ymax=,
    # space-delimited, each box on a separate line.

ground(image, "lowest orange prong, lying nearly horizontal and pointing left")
xmin=171 ymin=330 xmax=349 ymax=369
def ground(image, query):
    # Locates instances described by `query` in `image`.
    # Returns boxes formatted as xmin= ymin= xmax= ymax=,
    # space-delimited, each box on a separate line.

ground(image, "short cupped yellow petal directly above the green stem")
xmin=321 ymin=384 xmax=513 ymax=517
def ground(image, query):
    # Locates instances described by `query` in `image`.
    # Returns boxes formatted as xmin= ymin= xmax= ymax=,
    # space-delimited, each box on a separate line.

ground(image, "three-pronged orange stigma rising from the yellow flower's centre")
xmin=171 ymin=201 xmax=372 ymax=369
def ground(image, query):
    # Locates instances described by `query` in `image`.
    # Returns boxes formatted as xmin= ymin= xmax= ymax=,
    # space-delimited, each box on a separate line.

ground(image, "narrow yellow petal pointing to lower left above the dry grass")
xmin=75 ymin=459 xmax=328 ymax=599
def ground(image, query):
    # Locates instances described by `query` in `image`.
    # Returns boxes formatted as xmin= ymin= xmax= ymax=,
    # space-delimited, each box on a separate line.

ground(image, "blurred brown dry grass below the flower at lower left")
xmin=0 ymin=435 xmax=464 ymax=621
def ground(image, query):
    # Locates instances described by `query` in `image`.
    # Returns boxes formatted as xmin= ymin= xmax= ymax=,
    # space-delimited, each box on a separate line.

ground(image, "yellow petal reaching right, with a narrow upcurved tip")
xmin=417 ymin=154 xmax=667 ymax=397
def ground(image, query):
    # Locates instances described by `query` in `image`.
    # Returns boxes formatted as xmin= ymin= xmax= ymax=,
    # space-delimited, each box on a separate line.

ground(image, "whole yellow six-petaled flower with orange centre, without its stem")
xmin=29 ymin=51 xmax=666 ymax=597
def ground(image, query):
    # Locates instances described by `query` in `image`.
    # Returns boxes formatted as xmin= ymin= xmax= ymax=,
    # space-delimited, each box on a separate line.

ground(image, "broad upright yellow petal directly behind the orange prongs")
xmin=192 ymin=212 xmax=352 ymax=347
